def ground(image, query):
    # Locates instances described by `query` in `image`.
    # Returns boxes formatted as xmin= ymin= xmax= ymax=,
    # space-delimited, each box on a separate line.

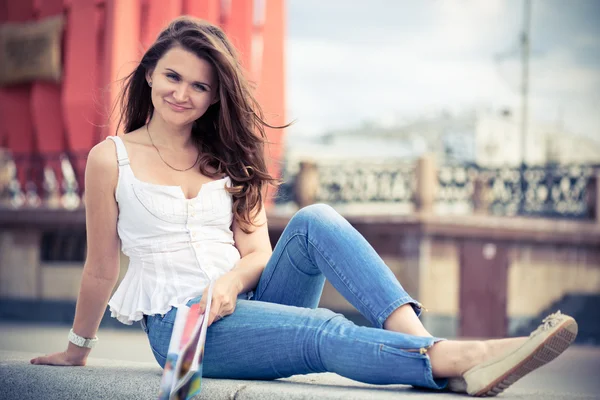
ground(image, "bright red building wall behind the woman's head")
xmin=0 ymin=0 xmax=285 ymax=206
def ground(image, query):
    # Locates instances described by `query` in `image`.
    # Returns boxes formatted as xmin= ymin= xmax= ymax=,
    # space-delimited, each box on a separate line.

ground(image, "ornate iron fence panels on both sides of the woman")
xmin=0 ymin=149 xmax=600 ymax=219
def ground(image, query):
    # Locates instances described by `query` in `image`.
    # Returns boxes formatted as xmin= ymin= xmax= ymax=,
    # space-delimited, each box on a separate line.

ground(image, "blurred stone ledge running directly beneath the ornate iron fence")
xmin=0 ymin=208 xmax=600 ymax=246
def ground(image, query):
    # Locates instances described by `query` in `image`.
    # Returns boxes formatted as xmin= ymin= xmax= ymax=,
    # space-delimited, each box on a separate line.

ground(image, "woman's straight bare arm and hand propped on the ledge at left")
xmin=31 ymin=140 xmax=119 ymax=365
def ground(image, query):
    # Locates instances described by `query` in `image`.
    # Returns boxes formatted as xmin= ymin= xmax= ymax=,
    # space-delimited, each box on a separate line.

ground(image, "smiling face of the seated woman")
xmin=146 ymin=47 xmax=218 ymax=126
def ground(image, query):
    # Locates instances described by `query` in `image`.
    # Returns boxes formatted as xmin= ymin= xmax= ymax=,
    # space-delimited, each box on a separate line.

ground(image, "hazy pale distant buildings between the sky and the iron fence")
xmin=286 ymin=111 xmax=600 ymax=169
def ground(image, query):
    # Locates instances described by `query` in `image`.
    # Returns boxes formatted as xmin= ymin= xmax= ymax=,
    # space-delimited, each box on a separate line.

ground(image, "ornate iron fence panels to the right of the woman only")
xmin=276 ymin=162 xmax=600 ymax=219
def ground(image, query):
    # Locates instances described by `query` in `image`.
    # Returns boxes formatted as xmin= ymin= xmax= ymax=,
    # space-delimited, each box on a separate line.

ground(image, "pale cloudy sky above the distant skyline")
xmin=286 ymin=0 xmax=600 ymax=140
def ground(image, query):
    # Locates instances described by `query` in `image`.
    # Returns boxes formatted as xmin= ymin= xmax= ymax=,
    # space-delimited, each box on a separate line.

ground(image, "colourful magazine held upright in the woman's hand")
xmin=158 ymin=282 xmax=213 ymax=400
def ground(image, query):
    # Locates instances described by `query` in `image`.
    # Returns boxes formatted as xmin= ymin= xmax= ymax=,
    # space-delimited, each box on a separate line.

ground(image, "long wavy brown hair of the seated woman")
xmin=117 ymin=16 xmax=287 ymax=233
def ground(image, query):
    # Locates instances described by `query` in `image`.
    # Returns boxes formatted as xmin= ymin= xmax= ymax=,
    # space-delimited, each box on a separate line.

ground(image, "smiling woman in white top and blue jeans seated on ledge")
xmin=31 ymin=17 xmax=577 ymax=395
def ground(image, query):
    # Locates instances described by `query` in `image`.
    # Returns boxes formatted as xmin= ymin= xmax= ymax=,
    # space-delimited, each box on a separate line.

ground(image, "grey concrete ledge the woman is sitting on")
xmin=0 ymin=350 xmax=597 ymax=400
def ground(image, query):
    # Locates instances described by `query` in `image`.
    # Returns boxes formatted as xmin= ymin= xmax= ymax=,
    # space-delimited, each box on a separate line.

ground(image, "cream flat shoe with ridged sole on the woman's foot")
xmin=449 ymin=311 xmax=577 ymax=396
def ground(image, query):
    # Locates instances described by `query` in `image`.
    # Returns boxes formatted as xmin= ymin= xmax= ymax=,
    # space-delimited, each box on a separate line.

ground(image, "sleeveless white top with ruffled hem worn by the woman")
xmin=108 ymin=136 xmax=240 ymax=325
